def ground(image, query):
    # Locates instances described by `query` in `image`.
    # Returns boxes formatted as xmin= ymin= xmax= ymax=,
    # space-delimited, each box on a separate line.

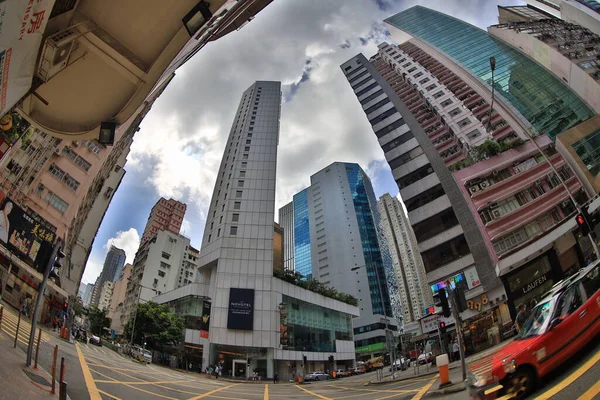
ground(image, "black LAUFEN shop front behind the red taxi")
xmin=502 ymin=249 xmax=564 ymax=319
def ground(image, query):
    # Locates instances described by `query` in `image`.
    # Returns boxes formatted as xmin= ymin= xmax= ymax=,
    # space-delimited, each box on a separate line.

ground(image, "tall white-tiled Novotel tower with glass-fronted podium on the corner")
xmin=156 ymin=81 xmax=358 ymax=379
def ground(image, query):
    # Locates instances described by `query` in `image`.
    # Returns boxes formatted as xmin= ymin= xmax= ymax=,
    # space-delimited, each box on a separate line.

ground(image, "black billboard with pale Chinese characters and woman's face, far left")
xmin=0 ymin=192 xmax=56 ymax=272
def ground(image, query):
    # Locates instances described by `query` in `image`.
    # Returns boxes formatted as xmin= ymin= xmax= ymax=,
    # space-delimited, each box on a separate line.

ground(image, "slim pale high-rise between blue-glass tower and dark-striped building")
xmin=377 ymin=193 xmax=433 ymax=324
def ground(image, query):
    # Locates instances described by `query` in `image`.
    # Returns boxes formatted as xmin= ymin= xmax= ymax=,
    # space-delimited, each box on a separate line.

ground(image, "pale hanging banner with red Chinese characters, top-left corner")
xmin=0 ymin=0 xmax=55 ymax=116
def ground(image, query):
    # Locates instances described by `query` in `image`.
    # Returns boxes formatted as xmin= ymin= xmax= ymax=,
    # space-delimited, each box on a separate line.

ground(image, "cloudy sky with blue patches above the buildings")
xmin=83 ymin=0 xmax=521 ymax=283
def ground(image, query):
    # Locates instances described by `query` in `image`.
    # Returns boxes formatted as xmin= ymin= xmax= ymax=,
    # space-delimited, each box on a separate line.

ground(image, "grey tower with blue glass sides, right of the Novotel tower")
xmin=280 ymin=162 xmax=402 ymax=358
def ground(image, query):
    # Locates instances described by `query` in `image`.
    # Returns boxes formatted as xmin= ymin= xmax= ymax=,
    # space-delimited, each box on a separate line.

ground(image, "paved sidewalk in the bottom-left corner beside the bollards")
xmin=0 ymin=333 xmax=65 ymax=400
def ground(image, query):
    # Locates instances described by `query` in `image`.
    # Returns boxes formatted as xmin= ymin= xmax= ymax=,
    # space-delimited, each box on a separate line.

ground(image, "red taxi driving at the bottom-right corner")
xmin=469 ymin=262 xmax=600 ymax=399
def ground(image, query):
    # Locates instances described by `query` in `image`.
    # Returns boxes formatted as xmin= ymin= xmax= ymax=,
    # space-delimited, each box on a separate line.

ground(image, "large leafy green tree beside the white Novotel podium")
xmin=125 ymin=301 xmax=185 ymax=349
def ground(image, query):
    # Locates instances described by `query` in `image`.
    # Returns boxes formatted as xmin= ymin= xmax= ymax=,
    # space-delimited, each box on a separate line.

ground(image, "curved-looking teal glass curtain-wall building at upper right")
xmin=384 ymin=6 xmax=594 ymax=139
